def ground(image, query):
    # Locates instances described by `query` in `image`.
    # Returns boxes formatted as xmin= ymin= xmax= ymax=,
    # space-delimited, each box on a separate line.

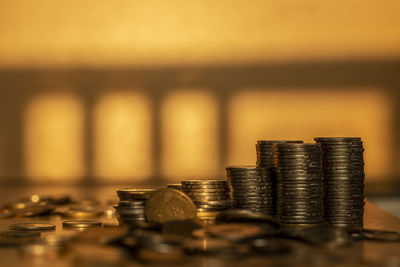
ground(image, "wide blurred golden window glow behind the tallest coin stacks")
xmin=228 ymin=89 xmax=392 ymax=179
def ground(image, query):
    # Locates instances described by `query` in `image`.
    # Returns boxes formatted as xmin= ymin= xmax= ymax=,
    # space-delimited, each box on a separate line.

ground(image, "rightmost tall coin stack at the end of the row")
xmin=315 ymin=137 xmax=365 ymax=230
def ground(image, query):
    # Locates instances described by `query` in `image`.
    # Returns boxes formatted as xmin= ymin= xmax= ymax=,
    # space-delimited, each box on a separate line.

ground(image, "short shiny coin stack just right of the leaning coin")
xmin=182 ymin=180 xmax=231 ymax=212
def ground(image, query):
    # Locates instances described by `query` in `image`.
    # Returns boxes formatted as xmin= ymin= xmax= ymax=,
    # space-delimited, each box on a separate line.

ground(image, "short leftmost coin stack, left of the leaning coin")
xmin=114 ymin=188 xmax=156 ymax=225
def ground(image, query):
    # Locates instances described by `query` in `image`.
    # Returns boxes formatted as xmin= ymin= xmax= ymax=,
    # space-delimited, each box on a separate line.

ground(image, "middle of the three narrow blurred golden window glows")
xmin=94 ymin=91 xmax=152 ymax=182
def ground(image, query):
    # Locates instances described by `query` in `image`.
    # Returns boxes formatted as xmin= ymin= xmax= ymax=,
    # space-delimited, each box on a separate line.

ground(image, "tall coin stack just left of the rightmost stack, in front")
xmin=275 ymin=143 xmax=324 ymax=225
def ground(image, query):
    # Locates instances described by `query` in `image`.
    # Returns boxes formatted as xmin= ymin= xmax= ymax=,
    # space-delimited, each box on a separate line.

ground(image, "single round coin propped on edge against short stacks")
xmin=145 ymin=188 xmax=197 ymax=223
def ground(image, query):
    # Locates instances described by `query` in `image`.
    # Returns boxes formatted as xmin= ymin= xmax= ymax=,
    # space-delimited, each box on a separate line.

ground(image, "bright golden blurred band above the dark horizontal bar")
xmin=0 ymin=0 xmax=400 ymax=65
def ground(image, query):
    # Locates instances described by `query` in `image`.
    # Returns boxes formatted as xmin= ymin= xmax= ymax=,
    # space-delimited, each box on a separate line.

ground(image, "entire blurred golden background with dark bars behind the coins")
xmin=0 ymin=0 xmax=400 ymax=194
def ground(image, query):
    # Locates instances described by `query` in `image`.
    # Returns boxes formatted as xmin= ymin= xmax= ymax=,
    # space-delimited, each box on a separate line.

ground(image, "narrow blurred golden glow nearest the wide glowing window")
xmin=162 ymin=90 xmax=219 ymax=181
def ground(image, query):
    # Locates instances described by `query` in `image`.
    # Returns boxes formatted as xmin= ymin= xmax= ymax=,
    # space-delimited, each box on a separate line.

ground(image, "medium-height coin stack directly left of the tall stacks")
xmin=225 ymin=165 xmax=274 ymax=215
